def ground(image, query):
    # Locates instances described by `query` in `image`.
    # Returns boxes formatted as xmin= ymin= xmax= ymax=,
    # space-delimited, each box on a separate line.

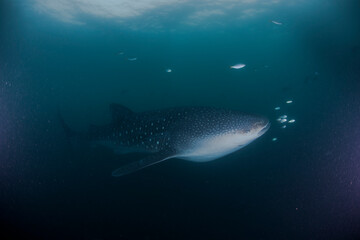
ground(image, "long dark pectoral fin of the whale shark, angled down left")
xmin=111 ymin=152 xmax=174 ymax=177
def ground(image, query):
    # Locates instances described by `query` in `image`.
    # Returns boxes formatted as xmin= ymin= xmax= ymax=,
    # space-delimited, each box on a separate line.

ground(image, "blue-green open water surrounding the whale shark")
xmin=0 ymin=0 xmax=360 ymax=239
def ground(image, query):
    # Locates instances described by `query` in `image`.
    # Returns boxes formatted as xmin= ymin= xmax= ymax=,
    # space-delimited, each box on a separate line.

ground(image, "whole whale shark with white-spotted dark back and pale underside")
xmin=61 ymin=103 xmax=270 ymax=177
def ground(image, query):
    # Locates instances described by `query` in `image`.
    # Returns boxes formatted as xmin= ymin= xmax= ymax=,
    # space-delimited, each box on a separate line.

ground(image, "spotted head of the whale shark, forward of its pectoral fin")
xmin=180 ymin=112 xmax=270 ymax=162
